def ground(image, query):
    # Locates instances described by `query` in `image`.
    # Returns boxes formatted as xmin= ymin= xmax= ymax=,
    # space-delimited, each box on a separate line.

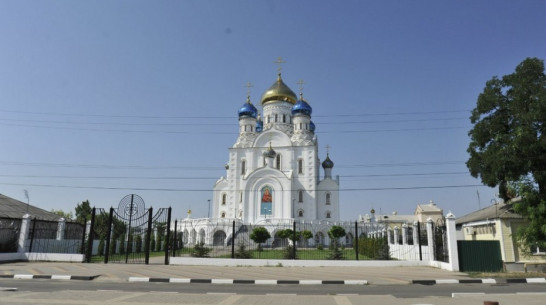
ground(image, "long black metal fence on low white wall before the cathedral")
xmin=172 ymin=219 xmax=444 ymax=260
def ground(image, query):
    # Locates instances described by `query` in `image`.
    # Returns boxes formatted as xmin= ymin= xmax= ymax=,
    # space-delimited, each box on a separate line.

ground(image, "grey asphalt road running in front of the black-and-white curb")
xmin=0 ymin=279 xmax=546 ymax=296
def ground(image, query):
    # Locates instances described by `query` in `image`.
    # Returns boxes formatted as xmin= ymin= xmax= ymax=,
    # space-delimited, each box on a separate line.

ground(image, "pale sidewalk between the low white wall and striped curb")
xmin=0 ymin=262 xmax=471 ymax=285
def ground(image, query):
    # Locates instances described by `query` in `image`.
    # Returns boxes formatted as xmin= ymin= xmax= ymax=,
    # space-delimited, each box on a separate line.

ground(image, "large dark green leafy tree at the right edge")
xmin=466 ymin=58 xmax=546 ymax=246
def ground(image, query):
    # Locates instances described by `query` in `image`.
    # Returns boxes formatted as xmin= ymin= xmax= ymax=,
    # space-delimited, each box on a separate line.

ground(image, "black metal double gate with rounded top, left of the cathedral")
xmin=86 ymin=194 xmax=171 ymax=265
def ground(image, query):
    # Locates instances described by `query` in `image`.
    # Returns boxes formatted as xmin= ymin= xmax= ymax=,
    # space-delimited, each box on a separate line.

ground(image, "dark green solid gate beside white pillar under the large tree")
xmin=457 ymin=240 xmax=502 ymax=272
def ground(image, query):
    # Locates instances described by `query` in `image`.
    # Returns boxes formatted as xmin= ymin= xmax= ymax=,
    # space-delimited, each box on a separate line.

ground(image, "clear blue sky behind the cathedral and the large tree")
xmin=0 ymin=0 xmax=546 ymax=220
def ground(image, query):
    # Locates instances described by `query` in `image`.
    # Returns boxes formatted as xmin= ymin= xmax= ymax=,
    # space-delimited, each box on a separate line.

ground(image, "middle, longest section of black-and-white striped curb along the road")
xmin=127 ymin=277 xmax=368 ymax=285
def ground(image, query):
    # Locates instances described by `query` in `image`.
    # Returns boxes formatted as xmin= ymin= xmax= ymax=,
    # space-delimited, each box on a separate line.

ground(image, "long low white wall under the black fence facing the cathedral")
xmin=169 ymin=257 xmax=431 ymax=267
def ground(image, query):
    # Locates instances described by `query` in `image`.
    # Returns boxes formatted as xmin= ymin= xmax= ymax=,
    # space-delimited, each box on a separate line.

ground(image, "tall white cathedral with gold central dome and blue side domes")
xmin=212 ymin=73 xmax=339 ymax=224
